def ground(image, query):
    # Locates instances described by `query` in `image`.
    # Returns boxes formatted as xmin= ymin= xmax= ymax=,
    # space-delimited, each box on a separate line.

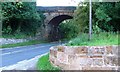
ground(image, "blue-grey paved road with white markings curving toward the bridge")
xmin=0 ymin=43 xmax=60 ymax=67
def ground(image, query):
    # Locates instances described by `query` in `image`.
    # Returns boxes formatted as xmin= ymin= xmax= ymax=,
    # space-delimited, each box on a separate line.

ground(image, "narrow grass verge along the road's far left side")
xmin=0 ymin=40 xmax=46 ymax=48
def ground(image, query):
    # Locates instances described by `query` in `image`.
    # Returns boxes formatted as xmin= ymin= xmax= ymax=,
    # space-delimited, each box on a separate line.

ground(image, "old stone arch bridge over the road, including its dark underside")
xmin=37 ymin=6 xmax=76 ymax=41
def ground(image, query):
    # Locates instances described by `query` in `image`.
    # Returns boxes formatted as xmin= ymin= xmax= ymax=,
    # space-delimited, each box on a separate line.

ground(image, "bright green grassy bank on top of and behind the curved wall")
xmin=66 ymin=32 xmax=120 ymax=46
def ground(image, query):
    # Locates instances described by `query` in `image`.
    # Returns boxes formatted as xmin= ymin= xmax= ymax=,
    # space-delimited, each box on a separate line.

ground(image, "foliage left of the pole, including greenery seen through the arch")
xmin=60 ymin=3 xmax=89 ymax=39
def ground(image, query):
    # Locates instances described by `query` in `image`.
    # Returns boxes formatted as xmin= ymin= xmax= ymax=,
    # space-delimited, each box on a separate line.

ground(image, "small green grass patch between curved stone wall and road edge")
xmin=37 ymin=54 xmax=60 ymax=72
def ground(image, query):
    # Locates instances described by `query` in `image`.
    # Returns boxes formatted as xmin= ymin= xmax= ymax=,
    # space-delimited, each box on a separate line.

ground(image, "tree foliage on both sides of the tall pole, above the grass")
xmin=70 ymin=2 xmax=120 ymax=33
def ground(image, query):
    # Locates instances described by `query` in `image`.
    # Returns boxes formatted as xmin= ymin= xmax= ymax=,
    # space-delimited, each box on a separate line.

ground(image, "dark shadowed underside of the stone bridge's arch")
xmin=48 ymin=15 xmax=73 ymax=41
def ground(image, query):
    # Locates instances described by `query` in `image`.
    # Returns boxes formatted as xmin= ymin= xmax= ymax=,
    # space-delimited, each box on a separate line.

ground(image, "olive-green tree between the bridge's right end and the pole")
xmin=73 ymin=3 xmax=89 ymax=32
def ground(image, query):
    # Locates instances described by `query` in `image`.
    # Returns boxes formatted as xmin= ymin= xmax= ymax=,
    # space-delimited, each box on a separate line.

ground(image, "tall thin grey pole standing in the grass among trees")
xmin=89 ymin=0 xmax=92 ymax=40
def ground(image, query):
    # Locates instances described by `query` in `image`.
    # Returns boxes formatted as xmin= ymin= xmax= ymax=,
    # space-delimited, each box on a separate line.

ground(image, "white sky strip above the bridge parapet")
xmin=36 ymin=0 xmax=80 ymax=6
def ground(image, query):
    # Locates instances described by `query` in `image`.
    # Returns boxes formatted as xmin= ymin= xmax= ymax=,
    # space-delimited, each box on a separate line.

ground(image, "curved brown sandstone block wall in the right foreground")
xmin=49 ymin=45 xmax=118 ymax=70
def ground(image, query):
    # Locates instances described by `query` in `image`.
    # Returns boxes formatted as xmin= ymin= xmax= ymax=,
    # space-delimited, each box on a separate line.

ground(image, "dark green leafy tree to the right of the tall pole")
xmin=94 ymin=2 xmax=120 ymax=31
